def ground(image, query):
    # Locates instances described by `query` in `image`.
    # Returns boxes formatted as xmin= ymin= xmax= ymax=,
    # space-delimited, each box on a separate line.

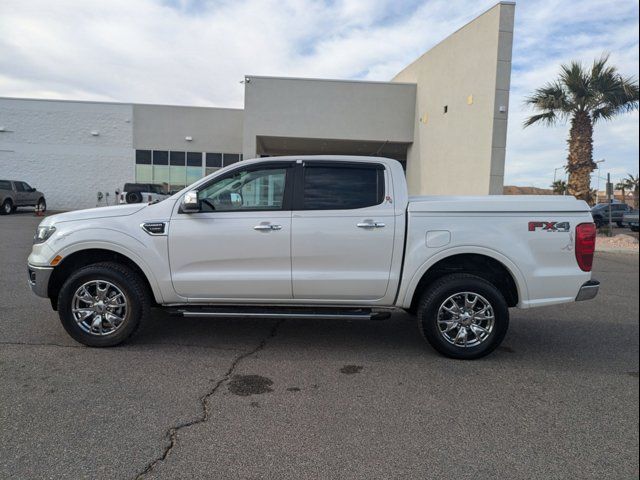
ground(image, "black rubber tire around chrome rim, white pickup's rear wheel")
xmin=417 ymin=273 xmax=509 ymax=360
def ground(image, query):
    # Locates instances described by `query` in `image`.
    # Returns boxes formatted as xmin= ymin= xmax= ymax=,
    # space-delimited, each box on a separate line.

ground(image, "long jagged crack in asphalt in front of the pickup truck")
xmin=135 ymin=320 xmax=284 ymax=480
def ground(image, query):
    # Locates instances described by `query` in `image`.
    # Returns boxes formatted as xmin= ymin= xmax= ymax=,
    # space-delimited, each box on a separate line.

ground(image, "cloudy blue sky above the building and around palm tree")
xmin=0 ymin=0 xmax=638 ymax=187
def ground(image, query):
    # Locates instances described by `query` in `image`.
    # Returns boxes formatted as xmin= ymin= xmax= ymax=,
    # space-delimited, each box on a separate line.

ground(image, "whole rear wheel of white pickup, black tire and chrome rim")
xmin=417 ymin=273 xmax=509 ymax=360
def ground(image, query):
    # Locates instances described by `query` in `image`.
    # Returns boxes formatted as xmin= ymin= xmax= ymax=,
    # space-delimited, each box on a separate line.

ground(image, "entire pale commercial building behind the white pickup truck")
xmin=0 ymin=2 xmax=515 ymax=209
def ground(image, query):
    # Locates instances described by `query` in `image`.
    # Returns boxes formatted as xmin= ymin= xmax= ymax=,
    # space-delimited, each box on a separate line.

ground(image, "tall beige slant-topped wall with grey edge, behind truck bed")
xmin=393 ymin=2 xmax=515 ymax=195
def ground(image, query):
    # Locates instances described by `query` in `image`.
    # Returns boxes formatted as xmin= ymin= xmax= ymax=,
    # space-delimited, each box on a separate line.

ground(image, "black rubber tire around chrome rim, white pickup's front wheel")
xmin=58 ymin=262 xmax=151 ymax=347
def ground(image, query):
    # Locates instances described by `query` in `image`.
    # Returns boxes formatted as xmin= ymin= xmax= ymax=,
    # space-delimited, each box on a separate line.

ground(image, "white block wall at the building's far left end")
xmin=0 ymin=98 xmax=134 ymax=210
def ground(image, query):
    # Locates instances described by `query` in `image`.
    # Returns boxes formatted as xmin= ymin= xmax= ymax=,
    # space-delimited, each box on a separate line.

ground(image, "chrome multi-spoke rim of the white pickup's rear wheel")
xmin=438 ymin=292 xmax=495 ymax=348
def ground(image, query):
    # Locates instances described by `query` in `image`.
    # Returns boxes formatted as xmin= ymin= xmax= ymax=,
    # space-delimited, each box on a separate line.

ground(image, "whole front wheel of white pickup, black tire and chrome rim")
xmin=58 ymin=262 xmax=150 ymax=347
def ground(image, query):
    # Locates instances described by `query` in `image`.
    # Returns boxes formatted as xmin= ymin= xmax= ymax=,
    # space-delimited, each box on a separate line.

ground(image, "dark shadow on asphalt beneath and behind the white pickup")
xmin=120 ymin=309 xmax=638 ymax=373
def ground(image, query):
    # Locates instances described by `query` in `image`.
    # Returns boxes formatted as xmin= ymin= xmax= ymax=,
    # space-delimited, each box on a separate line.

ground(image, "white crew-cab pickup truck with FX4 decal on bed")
xmin=28 ymin=156 xmax=599 ymax=359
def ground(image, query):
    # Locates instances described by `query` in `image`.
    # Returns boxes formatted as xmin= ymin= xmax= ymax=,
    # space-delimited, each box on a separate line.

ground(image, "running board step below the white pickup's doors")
xmin=170 ymin=306 xmax=391 ymax=320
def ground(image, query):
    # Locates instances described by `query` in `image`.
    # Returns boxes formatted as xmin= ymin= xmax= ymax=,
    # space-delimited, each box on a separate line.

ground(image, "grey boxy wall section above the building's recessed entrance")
xmin=242 ymin=76 xmax=416 ymax=158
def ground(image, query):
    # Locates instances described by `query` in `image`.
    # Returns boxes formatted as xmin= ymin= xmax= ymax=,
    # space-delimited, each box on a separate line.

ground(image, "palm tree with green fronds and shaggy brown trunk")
xmin=524 ymin=55 xmax=639 ymax=201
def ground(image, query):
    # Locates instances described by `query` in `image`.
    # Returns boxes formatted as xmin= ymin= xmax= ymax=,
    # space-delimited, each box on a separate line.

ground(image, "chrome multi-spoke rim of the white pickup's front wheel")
xmin=71 ymin=280 xmax=127 ymax=336
